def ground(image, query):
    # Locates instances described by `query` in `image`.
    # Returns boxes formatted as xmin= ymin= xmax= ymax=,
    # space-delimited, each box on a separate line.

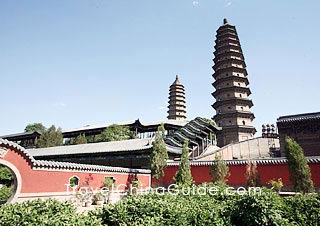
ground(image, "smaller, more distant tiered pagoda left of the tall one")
xmin=168 ymin=75 xmax=186 ymax=120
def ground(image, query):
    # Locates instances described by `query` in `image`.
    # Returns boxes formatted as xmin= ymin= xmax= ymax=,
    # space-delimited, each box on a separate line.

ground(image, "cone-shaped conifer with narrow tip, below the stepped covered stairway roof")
xmin=173 ymin=140 xmax=193 ymax=186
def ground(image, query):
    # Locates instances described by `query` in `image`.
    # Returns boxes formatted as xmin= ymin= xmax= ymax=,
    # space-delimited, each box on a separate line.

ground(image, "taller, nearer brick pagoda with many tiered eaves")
xmin=212 ymin=19 xmax=256 ymax=146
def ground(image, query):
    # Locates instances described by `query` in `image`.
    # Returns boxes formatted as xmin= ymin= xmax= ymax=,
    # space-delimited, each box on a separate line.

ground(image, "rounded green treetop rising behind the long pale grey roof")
xmin=97 ymin=124 xmax=135 ymax=142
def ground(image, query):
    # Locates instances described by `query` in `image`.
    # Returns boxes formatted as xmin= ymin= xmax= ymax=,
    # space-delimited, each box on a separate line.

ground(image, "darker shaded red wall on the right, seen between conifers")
xmin=152 ymin=163 xmax=320 ymax=187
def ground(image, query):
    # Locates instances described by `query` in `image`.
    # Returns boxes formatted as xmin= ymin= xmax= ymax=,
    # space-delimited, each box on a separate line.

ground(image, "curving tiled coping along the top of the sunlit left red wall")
xmin=0 ymin=138 xmax=150 ymax=174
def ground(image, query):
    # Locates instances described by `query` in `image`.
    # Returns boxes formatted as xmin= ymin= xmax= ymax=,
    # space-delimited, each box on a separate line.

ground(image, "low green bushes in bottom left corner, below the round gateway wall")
xmin=0 ymin=199 xmax=102 ymax=226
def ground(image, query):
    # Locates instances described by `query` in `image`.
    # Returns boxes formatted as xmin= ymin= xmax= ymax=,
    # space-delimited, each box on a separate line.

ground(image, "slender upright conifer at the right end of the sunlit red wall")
xmin=151 ymin=124 xmax=169 ymax=184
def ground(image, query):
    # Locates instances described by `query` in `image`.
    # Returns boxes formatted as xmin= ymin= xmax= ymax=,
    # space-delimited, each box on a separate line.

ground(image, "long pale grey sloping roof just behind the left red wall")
xmin=28 ymin=139 xmax=152 ymax=156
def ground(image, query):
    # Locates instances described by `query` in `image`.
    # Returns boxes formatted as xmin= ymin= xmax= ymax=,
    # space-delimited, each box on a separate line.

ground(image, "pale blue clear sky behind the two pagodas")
xmin=0 ymin=0 xmax=320 ymax=135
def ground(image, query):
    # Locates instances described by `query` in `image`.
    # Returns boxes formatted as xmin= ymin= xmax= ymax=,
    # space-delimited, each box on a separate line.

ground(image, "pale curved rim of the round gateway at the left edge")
xmin=0 ymin=159 xmax=22 ymax=203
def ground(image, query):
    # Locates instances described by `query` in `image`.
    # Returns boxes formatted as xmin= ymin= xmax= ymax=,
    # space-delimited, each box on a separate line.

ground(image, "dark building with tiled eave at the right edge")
xmin=277 ymin=112 xmax=320 ymax=156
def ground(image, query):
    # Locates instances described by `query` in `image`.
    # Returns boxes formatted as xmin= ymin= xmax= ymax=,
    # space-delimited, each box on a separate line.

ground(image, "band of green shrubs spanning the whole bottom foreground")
xmin=0 ymin=190 xmax=320 ymax=226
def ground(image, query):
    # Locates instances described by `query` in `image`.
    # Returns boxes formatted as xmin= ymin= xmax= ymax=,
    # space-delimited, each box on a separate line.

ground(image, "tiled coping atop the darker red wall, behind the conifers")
xmin=168 ymin=156 xmax=320 ymax=166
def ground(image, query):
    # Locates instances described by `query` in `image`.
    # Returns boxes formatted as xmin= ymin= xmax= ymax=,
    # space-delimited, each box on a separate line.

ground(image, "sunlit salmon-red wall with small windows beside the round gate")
xmin=4 ymin=150 xmax=150 ymax=193
